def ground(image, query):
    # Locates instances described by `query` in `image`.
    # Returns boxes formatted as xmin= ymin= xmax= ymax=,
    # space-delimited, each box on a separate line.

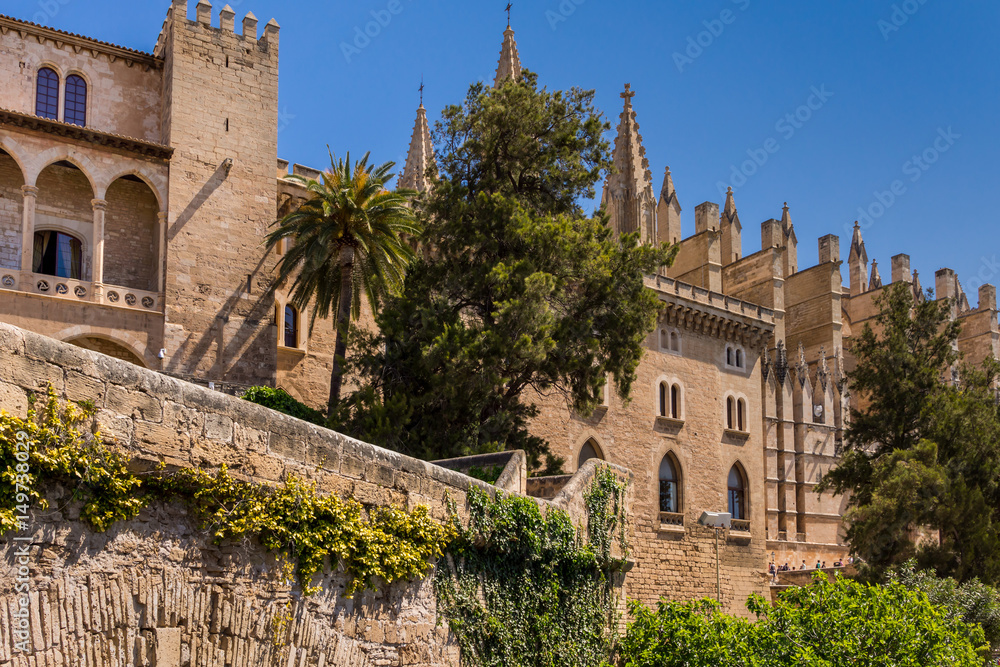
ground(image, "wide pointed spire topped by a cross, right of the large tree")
xmin=601 ymin=83 xmax=657 ymax=243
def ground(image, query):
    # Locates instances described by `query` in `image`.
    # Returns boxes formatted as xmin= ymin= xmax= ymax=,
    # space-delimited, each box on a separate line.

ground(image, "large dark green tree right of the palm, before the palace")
xmin=334 ymin=74 xmax=675 ymax=474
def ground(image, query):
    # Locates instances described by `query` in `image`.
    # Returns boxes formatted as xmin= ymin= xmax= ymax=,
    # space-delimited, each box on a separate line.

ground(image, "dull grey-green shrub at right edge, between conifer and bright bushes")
xmin=887 ymin=560 xmax=1000 ymax=649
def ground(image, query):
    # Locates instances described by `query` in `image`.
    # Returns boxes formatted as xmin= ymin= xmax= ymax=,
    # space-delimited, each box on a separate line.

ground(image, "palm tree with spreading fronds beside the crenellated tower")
xmin=265 ymin=152 xmax=419 ymax=415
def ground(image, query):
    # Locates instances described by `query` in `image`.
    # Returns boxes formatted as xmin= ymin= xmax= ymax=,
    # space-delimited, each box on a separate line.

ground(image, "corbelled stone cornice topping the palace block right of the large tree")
xmin=646 ymin=276 xmax=774 ymax=349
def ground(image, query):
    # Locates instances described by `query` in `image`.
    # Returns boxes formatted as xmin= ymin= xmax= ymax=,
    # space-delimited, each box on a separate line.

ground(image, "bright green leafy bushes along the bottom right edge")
xmin=621 ymin=574 xmax=987 ymax=667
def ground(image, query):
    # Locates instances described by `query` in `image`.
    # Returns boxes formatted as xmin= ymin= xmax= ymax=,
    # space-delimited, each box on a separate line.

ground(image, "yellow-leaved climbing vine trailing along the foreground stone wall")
xmin=0 ymin=387 xmax=455 ymax=595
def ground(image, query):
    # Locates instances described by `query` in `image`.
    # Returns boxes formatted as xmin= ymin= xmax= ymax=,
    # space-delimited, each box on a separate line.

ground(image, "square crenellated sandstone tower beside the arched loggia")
xmin=156 ymin=0 xmax=278 ymax=384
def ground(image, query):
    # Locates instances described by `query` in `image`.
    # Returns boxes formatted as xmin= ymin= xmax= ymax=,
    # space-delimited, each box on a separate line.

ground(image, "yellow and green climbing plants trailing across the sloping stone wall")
xmin=0 ymin=387 xmax=629 ymax=667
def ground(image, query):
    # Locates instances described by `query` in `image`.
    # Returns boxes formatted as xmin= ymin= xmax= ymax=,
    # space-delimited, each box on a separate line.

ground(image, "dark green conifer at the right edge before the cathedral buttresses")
xmin=819 ymin=284 xmax=1000 ymax=584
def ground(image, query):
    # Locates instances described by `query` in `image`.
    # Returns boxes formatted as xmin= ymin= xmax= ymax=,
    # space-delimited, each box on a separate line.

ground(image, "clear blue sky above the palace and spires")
xmin=13 ymin=0 xmax=1000 ymax=303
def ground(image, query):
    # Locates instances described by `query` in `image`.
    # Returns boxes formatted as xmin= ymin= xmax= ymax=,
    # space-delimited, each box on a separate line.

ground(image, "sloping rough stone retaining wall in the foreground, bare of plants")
xmin=0 ymin=324 xmax=627 ymax=667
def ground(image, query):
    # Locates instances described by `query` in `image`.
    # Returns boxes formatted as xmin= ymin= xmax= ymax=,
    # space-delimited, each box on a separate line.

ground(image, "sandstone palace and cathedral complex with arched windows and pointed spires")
xmin=0 ymin=0 xmax=1000 ymax=609
